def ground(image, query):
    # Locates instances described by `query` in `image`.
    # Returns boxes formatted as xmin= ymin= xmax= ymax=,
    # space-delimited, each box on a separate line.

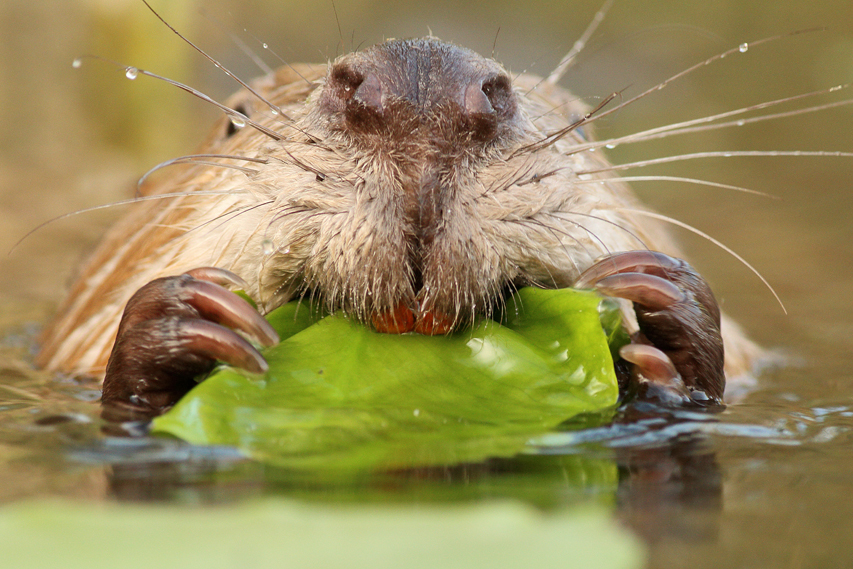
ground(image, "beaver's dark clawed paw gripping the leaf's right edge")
xmin=575 ymin=251 xmax=726 ymax=405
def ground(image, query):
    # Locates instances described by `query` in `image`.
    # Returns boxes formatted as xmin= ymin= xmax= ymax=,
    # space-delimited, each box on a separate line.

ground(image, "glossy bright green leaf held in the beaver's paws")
xmin=154 ymin=288 xmax=618 ymax=477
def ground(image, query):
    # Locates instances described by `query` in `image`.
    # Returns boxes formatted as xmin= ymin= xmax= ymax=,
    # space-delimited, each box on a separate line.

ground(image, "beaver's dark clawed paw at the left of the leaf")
xmin=102 ymin=267 xmax=278 ymax=412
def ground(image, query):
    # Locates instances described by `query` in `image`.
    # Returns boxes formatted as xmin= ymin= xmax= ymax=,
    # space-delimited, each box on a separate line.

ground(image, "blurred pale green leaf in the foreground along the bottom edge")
xmin=0 ymin=500 xmax=646 ymax=569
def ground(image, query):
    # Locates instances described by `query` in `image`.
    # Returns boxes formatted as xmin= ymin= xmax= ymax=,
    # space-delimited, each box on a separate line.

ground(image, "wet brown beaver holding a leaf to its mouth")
xmin=33 ymin=37 xmax=758 ymax=413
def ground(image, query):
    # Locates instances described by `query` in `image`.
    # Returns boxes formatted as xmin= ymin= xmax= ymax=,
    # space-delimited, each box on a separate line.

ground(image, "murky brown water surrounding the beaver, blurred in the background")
xmin=0 ymin=0 xmax=853 ymax=567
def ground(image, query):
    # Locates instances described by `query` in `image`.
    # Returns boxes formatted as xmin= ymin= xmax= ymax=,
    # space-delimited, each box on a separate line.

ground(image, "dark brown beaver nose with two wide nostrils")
xmin=320 ymin=39 xmax=517 ymax=139
